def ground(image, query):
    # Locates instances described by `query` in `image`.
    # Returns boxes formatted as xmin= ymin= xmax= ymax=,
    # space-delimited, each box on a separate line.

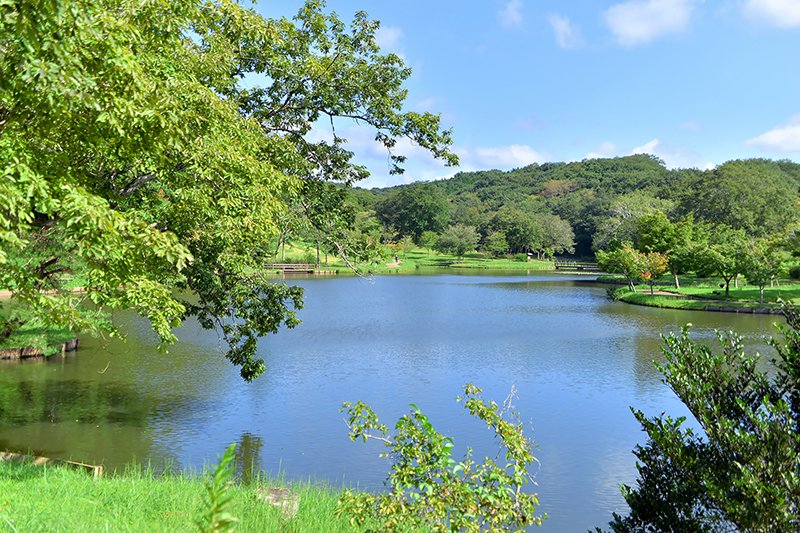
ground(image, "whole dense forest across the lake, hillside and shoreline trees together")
xmin=351 ymin=155 xmax=800 ymax=257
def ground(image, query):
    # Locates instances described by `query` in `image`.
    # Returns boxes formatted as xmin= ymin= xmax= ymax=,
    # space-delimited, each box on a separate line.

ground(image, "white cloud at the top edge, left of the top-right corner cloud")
xmin=604 ymin=0 xmax=694 ymax=46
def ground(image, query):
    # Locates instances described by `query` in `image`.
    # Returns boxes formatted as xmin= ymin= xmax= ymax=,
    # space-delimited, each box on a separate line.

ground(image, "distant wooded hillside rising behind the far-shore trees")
xmin=352 ymin=155 xmax=800 ymax=255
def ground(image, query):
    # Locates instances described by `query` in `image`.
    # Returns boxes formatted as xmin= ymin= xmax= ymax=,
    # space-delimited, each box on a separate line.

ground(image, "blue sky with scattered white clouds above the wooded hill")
xmin=257 ymin=0 xmax=800 ymax=187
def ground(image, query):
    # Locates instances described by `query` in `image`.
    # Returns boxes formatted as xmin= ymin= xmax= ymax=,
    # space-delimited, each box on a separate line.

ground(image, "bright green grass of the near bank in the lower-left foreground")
xmin=0 ymin=462 xmax=352 ymax=532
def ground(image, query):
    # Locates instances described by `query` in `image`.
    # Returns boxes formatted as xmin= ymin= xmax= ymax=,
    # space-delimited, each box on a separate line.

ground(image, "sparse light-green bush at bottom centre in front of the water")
xmin=336 ymin=384 xmax=546 ymax=531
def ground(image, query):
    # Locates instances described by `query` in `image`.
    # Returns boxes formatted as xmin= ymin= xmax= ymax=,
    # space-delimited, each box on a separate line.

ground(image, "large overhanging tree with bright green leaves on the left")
xmin=0 ymin=0 xmax=457 ymax=380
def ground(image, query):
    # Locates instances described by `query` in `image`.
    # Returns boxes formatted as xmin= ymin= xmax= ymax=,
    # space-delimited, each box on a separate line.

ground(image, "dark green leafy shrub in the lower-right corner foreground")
xmin=610 ymin=307 xmax=800 ymax=532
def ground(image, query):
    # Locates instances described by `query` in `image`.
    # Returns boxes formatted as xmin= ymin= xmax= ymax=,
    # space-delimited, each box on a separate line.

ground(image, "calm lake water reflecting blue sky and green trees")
xmin=0 ymin=275 xmax=780 ymax=532
